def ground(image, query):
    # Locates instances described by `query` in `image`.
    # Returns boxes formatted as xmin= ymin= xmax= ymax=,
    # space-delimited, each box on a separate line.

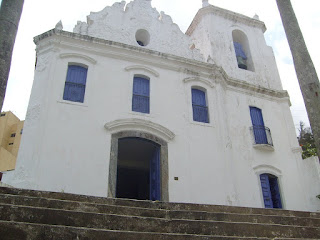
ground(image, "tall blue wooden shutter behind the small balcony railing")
xmin=250 ymin=107 xmax=268 ymax=144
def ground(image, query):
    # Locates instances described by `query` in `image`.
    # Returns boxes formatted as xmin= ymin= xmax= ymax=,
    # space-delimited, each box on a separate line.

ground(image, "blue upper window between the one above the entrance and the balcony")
xmin=191 ymin=88 xmax=209 ymax=123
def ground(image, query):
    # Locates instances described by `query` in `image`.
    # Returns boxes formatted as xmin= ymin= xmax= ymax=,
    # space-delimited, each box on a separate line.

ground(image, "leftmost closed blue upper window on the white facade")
xmin=63 ymin=65 xmax=88 ymax=103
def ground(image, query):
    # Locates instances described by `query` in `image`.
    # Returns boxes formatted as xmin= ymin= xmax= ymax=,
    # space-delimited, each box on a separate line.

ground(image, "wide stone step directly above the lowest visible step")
xmin=0 ymin=204 xmax=320 ymax=239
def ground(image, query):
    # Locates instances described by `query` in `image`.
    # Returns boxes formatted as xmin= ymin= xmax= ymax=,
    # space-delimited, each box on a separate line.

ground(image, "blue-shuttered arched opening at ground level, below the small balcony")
xmin=260 ymin=173 xmax=282 ymax=208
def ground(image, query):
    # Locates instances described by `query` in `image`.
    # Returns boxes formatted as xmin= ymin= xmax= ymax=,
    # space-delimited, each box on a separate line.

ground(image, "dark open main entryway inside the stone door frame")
xmin=116 ymin=137 xmax=161 ymax=200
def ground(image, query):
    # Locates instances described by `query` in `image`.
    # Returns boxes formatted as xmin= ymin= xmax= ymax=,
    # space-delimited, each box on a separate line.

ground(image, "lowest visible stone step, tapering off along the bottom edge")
xmin=0 ymin=221 xmax=276 ymax=240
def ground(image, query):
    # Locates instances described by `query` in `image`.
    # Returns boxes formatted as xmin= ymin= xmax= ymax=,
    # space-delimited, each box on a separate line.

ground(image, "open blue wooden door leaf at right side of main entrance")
xmin=150 ymin=146 xmax=161 ymax=201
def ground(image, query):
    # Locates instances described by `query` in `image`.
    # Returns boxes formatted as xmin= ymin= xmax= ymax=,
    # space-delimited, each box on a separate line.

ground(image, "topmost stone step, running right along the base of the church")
xmin=0 ymin=187 xmax=320 ymax=219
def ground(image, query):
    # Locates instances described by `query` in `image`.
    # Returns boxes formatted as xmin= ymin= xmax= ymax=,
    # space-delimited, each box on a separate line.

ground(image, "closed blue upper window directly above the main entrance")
xmin=132 ymin=77 xmax=150 ymax=113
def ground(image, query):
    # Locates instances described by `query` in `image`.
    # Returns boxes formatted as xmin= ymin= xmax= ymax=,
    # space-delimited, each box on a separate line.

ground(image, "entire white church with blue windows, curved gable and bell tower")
xmin=3 ymin=0 xmax=320 ymax=211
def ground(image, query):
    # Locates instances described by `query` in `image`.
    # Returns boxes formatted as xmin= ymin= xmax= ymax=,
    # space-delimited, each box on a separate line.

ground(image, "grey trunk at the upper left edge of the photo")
xmin=0 ymin=0 xmax=24 ymax=112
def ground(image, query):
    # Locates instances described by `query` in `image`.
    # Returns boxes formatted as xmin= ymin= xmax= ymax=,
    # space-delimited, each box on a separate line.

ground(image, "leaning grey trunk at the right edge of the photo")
xmin=276 ymin=0 xmax=320 ymax=159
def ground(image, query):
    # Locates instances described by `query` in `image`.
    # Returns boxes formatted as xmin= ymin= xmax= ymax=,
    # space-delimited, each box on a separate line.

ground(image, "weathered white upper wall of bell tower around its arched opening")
xmin=187 ymin=5 xmax=282 ymax=90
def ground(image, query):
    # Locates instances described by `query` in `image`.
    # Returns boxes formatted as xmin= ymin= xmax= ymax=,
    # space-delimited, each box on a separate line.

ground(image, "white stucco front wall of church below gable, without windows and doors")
xmin=3 ymin=0 xmax=320 ymax=211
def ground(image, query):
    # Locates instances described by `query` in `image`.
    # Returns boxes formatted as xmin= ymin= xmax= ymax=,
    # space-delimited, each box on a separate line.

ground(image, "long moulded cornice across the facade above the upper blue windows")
xmin=34 ymin=29 xmax=289 ymax=101
